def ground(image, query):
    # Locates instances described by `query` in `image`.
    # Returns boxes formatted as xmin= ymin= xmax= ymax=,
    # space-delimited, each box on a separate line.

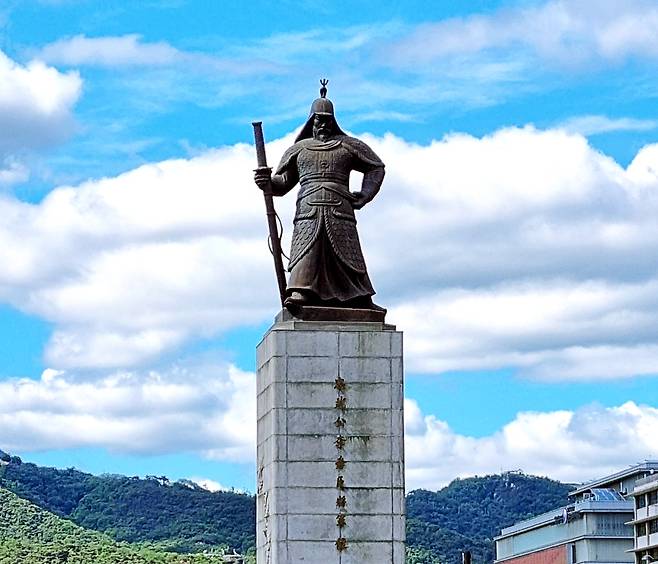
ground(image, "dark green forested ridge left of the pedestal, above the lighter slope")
xmin=0 ymin=457 xmax=256 ymax=554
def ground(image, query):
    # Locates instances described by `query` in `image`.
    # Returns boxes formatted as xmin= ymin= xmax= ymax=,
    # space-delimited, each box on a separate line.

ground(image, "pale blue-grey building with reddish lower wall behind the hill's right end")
xmin=495 ymin=461 xmax=658 ymax=564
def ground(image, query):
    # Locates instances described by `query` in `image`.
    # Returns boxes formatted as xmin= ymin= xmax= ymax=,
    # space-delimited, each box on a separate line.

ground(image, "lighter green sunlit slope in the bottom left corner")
xmin=0 ymin=488 xmax=233 ymax=564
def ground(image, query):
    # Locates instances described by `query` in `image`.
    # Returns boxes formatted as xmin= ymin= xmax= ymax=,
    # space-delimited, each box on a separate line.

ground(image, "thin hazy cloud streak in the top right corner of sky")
xmin=391 ymin=0 xmax=658 ymax=64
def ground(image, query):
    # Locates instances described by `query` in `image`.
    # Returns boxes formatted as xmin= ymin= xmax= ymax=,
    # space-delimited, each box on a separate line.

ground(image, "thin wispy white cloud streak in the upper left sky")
xmin=38 ymin=34 xmax=183 ymax=66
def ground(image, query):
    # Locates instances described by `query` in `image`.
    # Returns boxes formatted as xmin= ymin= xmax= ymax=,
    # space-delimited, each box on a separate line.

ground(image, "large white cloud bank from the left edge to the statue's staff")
xmin=0 ymin=139 xmax=292 ymax=368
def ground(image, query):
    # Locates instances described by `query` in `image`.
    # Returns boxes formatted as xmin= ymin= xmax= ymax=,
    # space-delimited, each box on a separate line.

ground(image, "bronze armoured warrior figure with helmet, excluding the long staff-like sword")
xmin=255 ymin=82 xmax=384 ymax=311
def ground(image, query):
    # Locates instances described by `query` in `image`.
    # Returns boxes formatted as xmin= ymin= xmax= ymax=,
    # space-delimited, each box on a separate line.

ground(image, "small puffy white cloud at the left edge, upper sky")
xmin=0 ymin=51 xmax=82 ymax=156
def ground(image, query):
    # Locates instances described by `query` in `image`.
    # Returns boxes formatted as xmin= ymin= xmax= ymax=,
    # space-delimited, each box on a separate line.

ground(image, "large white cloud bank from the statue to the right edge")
xmin=361 ymin=128 xmax=658 ymax=379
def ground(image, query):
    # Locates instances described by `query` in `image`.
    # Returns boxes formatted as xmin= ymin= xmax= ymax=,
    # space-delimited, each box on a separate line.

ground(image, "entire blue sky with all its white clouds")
xmin=0 ymin=0 xmax=658 ymax=492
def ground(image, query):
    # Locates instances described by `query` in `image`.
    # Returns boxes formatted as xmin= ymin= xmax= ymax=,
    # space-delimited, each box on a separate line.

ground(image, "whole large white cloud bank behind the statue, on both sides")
xmin=0 ymin=127 xmax=658 ymax=380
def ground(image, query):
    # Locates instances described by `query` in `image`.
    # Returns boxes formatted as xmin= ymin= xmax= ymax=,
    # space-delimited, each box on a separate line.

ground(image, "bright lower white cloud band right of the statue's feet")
xmin=391 ymin=281 xmax=658 ymax=380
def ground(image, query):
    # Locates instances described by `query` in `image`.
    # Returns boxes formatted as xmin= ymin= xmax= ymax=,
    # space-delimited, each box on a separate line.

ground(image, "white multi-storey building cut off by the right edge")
xmin=629 ymin=473 xmax=658 ymax=564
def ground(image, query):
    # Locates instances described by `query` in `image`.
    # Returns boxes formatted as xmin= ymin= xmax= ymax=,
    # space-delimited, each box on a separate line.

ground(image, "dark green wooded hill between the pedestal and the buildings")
xmin=407 ymin=472 xmax=571 ymax=564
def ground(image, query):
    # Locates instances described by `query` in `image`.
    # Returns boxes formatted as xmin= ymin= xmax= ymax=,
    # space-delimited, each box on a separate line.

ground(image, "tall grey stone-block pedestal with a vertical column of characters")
xmin=256 ymin=317 xmax=405 ymax=564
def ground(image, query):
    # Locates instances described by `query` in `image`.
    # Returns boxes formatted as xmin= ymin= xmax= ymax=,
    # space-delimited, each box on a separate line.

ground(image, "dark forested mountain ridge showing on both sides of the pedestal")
xmin=0 ymin=455 xmax=571 ymax=564
